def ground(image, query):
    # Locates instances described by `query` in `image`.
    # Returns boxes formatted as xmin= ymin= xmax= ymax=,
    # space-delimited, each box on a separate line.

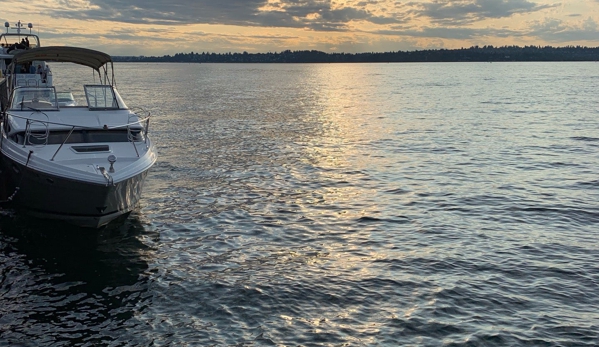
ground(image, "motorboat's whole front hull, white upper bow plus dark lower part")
xmin=0 ymin=128 xmax=156 ymax=228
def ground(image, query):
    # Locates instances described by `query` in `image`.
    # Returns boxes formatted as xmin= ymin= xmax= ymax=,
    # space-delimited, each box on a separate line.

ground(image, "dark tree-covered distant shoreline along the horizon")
xmin=112 ymin=46 xmax=599 ymax=63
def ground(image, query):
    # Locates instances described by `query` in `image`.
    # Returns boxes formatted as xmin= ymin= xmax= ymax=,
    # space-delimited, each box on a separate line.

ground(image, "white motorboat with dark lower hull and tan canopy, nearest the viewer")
xmin=0 ymin=41 xmax=156 ymax=228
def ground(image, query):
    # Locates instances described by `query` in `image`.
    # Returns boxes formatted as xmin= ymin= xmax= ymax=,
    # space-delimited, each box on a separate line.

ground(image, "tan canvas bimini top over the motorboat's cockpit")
xmin=12 ymin=46 xmax=112 ymax=71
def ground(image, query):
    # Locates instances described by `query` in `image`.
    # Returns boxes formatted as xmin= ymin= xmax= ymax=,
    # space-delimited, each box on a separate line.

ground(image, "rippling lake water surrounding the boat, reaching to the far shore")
xmin=0 ymin=63 xmax=599 ymax=346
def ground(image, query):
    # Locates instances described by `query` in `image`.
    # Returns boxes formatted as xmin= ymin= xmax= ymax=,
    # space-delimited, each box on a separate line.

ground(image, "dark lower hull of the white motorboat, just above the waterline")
xmin=2 ymin=156 xmax=148 ymax=228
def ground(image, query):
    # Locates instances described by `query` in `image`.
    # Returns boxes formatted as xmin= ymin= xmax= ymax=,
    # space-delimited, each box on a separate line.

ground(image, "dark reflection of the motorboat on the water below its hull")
xmin=0 ymin=212 xmax=158 ymax=346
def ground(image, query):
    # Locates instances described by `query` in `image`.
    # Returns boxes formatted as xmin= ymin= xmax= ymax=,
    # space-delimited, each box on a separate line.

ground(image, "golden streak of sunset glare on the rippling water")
xmin=288 ymin=65 xmax=400 ymax=226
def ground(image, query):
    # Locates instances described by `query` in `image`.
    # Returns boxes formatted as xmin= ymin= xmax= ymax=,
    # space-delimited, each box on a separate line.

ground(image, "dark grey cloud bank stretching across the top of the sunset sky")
xmin=50 ymin=0 xmax=599 ymax=43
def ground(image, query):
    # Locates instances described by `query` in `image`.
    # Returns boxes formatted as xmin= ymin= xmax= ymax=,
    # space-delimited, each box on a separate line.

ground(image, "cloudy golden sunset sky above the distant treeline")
xmin=0 ymin=0 xmax=599 ymax=56
